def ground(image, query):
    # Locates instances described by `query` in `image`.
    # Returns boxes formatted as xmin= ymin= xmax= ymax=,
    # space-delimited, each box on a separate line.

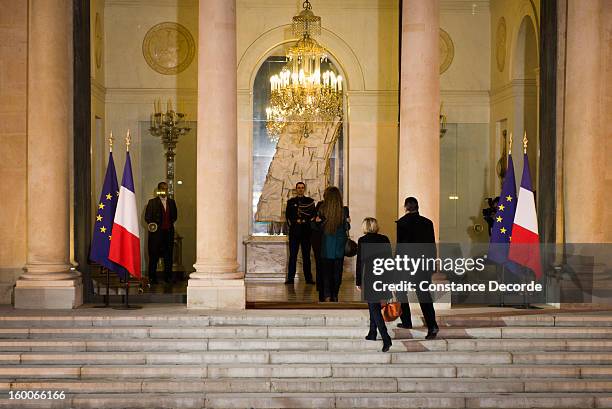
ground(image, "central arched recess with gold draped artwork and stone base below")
xmin=245 ymin=41 xmax=359 ymax=308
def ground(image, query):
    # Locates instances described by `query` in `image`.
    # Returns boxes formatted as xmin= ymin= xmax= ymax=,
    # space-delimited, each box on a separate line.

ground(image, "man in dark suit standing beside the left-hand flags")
xmin=145 ymin=182 xmax=178 ymax=284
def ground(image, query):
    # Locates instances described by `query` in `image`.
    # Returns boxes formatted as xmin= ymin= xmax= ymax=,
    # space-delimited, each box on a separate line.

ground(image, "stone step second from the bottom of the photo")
xmin=0 ymin=378 xmax=612 ymax=394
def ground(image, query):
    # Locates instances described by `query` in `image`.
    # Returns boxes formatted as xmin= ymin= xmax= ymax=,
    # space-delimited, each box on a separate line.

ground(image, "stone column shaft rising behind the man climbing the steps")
xmin=398 ymin=0 xmax=440 ymax=233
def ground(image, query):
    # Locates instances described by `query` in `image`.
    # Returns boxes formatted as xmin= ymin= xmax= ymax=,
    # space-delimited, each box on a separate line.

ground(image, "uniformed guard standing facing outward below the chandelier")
xmin=285 ymin=182 xmax=315 ymax=284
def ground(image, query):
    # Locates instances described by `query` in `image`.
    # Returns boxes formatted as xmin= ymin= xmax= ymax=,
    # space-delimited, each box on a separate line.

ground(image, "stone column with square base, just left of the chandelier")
xmin=187 ymin=0 xmax=246 ymax=309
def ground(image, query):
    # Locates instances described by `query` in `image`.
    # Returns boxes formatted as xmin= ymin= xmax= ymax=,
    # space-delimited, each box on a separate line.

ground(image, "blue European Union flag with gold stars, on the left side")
xmin=89 ymin=152 xmax=127 ymax=278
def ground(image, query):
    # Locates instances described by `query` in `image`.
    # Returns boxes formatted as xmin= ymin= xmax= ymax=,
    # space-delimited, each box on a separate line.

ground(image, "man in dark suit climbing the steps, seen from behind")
xmin=396 ymin=197 xmax=438 ymax=339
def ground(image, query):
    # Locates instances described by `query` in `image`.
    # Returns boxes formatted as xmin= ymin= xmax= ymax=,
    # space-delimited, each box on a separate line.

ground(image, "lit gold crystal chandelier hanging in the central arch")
xmin=266 ymin=0 xmax=342 ymax=142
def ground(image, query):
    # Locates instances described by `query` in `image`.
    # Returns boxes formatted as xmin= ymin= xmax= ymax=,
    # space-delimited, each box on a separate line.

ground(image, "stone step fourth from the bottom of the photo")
xmin=0 ymin=351 xmax=612 ymax=365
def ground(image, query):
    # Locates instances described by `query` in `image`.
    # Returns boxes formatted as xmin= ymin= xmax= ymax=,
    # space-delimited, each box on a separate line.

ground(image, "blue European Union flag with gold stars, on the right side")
xmin=489 ymin=155 xmax=520 ymax=272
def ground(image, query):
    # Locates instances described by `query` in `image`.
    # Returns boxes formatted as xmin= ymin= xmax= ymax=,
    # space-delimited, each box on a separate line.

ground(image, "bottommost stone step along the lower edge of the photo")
xmin=0 ymin=393 xmax=612 ymax=409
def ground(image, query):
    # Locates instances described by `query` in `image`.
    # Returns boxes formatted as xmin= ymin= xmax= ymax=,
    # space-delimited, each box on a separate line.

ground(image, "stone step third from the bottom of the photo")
xmin=0 ymin=363 xmax=612 ymax=381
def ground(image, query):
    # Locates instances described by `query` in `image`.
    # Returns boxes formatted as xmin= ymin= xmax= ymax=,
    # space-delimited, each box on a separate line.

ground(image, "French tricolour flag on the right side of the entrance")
xmin=508 ymin=153 xmax=542 ymax=279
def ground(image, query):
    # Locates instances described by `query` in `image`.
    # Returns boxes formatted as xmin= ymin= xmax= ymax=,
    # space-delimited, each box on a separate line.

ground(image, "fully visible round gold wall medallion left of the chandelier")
xmin=142 ymin=22 xmax=195 ymax=75
